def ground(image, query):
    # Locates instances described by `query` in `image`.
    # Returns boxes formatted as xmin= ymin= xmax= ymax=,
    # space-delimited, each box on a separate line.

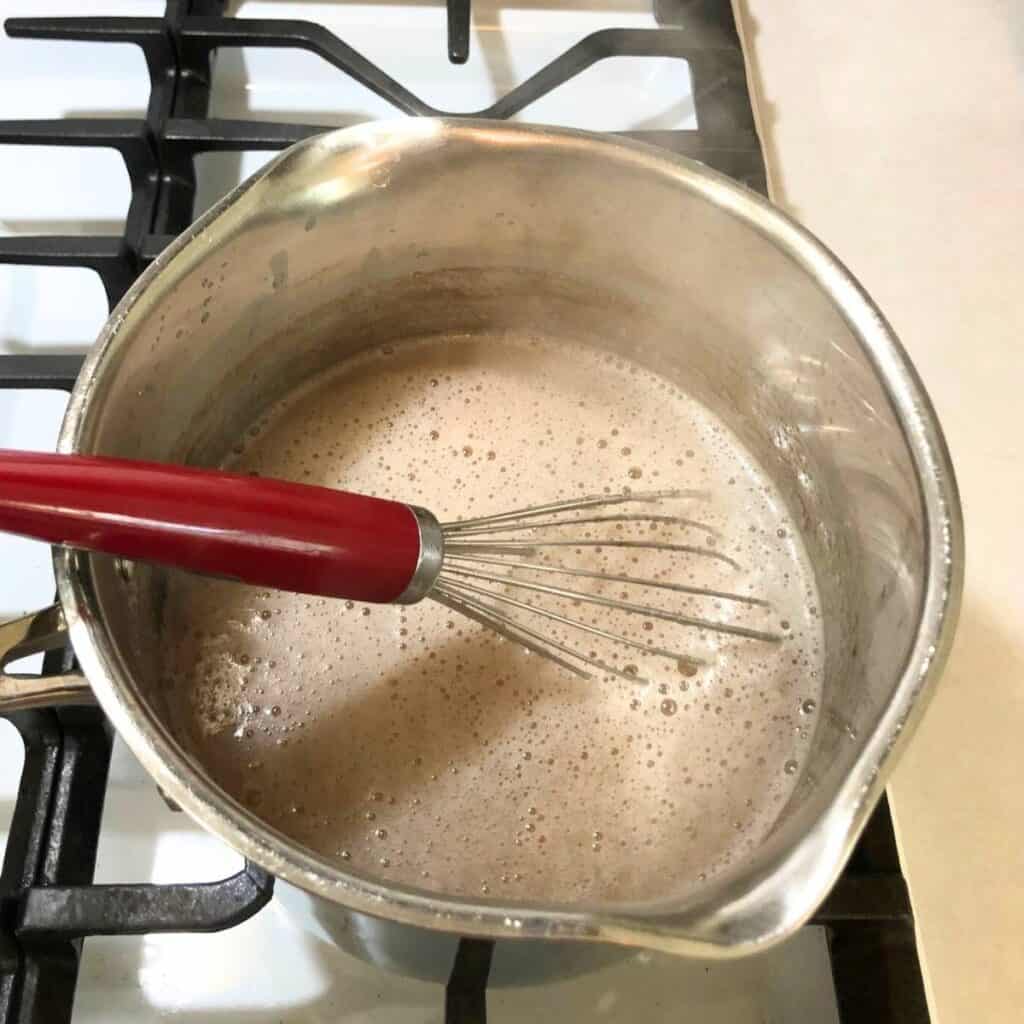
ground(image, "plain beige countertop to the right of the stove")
xmin=737 ymin=0 xmax=1024 ymax=1024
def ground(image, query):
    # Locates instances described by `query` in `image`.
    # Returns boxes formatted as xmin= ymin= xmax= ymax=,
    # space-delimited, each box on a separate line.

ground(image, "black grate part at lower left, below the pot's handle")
xmin=0 ymin=700 xmax=272 ymax=1024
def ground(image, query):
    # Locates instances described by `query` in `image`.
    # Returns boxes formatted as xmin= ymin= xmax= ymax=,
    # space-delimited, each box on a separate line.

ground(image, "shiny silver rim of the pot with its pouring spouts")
xmin=54 ymin=119 xmax=964 ymax=956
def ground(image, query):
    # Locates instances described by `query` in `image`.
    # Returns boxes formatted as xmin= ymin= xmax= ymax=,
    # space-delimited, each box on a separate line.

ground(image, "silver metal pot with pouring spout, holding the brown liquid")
xmin=0 ymin=120 xmax=964 ymax=956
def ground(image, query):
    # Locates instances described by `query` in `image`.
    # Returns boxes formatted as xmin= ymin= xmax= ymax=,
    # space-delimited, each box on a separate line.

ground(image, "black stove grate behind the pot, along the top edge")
xmin=0 ymin=0 xmax=765 ymax=315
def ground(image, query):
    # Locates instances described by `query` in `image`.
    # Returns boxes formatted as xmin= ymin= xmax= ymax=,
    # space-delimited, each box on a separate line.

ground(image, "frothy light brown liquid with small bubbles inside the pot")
xmin=159 ymin=336 xmax=821 ymax=902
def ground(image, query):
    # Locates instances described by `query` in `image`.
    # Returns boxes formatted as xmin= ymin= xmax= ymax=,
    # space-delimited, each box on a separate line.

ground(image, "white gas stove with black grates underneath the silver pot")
xmin=0 ymin=0 xmax=928 ymax=1024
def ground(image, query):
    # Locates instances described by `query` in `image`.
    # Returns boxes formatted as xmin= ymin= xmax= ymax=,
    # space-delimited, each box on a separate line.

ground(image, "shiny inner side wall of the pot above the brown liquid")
xmin=68 ymin=134 xmax=926 ymax=905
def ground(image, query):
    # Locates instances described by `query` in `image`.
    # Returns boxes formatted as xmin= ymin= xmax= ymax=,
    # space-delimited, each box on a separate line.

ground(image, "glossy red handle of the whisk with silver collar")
xmin=0 ymin=449 xmax=441 ymax=603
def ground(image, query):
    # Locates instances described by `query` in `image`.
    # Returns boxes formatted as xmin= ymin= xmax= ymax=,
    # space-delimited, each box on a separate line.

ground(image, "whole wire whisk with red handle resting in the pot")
xmin=0 ymin=450 xmax=780 ymax=678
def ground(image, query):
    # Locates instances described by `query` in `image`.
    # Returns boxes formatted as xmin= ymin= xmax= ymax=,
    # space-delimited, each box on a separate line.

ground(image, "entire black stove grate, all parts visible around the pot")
xmin=0 ymin=0 xmax=929 ymax=1024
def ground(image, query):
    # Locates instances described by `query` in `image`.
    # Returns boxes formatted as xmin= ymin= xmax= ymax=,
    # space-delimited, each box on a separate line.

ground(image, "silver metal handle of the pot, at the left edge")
xmin=0 ymin=604 xmax=96 ymax=714
